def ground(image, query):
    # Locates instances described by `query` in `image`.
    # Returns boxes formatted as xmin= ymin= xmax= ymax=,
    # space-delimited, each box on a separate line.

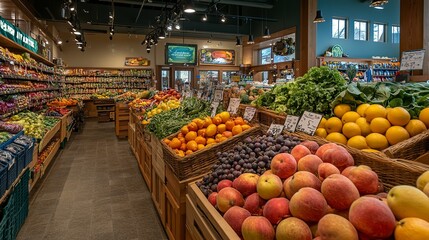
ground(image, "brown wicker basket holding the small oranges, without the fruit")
xmin=160 ymin=125 xmax=261 ymax=180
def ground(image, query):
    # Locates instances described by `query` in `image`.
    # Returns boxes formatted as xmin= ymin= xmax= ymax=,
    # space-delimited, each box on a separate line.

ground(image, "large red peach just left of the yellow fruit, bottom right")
xmin=349 ymin=197 xmax=396 ymax=239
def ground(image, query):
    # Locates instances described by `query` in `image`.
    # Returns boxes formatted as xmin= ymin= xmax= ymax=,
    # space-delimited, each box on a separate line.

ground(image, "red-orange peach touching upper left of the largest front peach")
xmin=321 ymin=174 xmax=360 ymax=210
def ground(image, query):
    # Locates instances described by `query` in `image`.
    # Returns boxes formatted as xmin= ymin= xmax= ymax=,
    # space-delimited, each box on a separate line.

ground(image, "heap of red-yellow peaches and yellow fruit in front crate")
xmin=208 ymin=141 xmax=429 ymax=240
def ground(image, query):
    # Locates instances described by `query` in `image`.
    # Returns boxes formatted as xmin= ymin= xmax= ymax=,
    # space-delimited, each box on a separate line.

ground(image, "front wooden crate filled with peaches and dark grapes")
xmin=187 ymin=136 xmax=429 ymax=240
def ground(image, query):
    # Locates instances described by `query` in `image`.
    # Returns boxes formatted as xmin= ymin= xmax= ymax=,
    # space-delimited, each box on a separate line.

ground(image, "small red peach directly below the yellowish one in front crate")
xmin=262 ymin=198 xmax=289 ymax=225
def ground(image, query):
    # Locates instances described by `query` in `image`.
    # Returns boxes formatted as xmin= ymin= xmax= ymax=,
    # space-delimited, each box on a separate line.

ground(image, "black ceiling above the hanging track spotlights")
xmin=25 ymin=0 xmax=278 ymax=39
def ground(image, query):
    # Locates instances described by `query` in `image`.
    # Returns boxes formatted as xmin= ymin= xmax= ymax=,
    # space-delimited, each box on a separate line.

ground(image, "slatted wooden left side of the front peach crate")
xmin=186 ymin=183 xmax=240 ymax=240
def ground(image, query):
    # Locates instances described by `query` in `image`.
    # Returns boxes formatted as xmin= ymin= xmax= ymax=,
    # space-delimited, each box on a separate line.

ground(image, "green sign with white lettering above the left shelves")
xmin=0 ymin=17 xmax=39 ymax=53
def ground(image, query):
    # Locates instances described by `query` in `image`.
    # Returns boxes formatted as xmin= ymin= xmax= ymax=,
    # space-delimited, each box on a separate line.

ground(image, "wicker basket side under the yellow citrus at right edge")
xmin=383 ymin=130 xmax=429 ymax=160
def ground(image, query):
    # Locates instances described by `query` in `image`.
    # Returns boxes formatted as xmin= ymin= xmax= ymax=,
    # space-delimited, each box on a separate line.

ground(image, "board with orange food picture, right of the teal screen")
xmin=200 ymin=49 xmax=235 ymax=65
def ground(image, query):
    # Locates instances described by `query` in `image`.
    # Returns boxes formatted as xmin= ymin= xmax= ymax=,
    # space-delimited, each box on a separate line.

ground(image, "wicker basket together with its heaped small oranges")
xmin=161 ymin=112 xmax=259 ymax=180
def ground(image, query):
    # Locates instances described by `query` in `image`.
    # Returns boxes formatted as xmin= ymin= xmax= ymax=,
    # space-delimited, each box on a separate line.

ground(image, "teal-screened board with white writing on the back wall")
xmin=165 ymin=43 xmax=197 ymax=65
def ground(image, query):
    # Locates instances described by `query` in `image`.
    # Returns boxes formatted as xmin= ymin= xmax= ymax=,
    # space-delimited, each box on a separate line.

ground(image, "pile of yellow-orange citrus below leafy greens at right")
xmin=315 ymin=103 xmax=429 ymax=151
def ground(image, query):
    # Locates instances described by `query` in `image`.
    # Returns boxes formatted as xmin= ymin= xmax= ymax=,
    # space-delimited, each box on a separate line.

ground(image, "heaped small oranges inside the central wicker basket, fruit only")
xmin=163 ymin=112 xmax=251 ymax=157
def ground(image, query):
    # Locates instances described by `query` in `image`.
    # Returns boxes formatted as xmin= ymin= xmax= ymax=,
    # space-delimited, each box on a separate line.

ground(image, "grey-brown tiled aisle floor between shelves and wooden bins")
xmin=18 ymin=121 xmax=167 ymax=240
